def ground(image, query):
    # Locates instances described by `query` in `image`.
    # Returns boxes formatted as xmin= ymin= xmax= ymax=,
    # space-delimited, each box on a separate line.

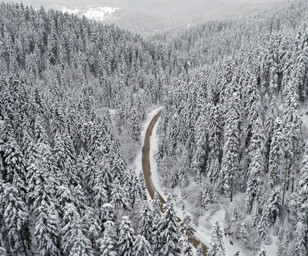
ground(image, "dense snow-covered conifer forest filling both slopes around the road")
xmin=0 ymin=0 xmax=308 ymax=256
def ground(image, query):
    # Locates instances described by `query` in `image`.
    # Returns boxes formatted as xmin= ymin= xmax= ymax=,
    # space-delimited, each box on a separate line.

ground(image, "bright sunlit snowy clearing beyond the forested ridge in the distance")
xmin=58 ymin=6 xmax=119 ymax=21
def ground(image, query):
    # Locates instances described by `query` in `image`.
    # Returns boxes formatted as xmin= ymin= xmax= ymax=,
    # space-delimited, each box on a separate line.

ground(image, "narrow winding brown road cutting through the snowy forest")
xmin=142 ymin=110 xmax=207 ymax=255
